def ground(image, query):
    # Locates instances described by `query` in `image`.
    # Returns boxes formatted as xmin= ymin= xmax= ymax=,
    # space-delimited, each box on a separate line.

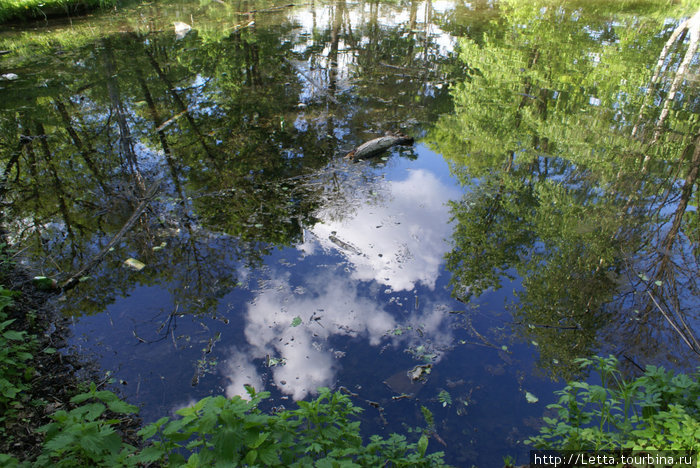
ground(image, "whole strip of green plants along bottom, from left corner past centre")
xmin=9 ymin=384 xmax=444 ymax=467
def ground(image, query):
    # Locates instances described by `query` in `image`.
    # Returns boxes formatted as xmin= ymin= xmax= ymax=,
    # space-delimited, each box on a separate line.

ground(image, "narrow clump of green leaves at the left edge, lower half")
xmin=0 ymin=286 xmax=36 ymax=436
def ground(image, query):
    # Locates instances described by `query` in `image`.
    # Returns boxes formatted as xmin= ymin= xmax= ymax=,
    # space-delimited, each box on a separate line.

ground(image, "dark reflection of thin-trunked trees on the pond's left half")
xmin=0 ymin=1 xmax=470 ymax=330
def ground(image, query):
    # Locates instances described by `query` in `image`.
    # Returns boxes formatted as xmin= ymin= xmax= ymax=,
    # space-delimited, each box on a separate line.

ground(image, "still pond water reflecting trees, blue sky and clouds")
xmin=0 ymin=1 xmax=700 ymax=466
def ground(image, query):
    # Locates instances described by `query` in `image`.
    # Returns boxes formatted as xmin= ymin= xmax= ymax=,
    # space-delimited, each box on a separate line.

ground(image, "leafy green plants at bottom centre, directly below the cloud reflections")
xmin=141 ymin=387 xmax=442 ymax=466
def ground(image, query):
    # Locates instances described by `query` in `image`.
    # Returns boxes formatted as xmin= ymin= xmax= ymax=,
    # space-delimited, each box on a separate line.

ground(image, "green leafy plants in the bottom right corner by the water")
xmin=526 ymin=356 xmax=700 ymax=450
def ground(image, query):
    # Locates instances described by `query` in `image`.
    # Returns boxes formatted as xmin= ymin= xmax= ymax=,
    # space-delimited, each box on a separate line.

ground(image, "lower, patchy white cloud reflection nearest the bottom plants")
xmin=224 ymin=265 xmax=460 ymax=400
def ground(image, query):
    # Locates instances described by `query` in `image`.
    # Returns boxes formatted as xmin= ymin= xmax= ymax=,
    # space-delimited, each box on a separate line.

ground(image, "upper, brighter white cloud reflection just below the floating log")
xmin=305 ymin=169 xmax=457 ymax=291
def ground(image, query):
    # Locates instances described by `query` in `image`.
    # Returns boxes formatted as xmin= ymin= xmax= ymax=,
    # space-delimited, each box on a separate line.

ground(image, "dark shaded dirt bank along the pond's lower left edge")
xmin=0 ymin=244 xmax=141 ymax=461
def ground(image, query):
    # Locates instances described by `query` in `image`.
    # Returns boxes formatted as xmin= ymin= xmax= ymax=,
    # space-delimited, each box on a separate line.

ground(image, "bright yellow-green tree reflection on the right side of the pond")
xmin=429 ymin=1 xmax=698 ymax=375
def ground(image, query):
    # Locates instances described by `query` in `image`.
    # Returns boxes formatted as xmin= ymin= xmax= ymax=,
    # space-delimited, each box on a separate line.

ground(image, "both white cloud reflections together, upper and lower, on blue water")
xmin=224 ymin=157 xmax=456 ymax=399
